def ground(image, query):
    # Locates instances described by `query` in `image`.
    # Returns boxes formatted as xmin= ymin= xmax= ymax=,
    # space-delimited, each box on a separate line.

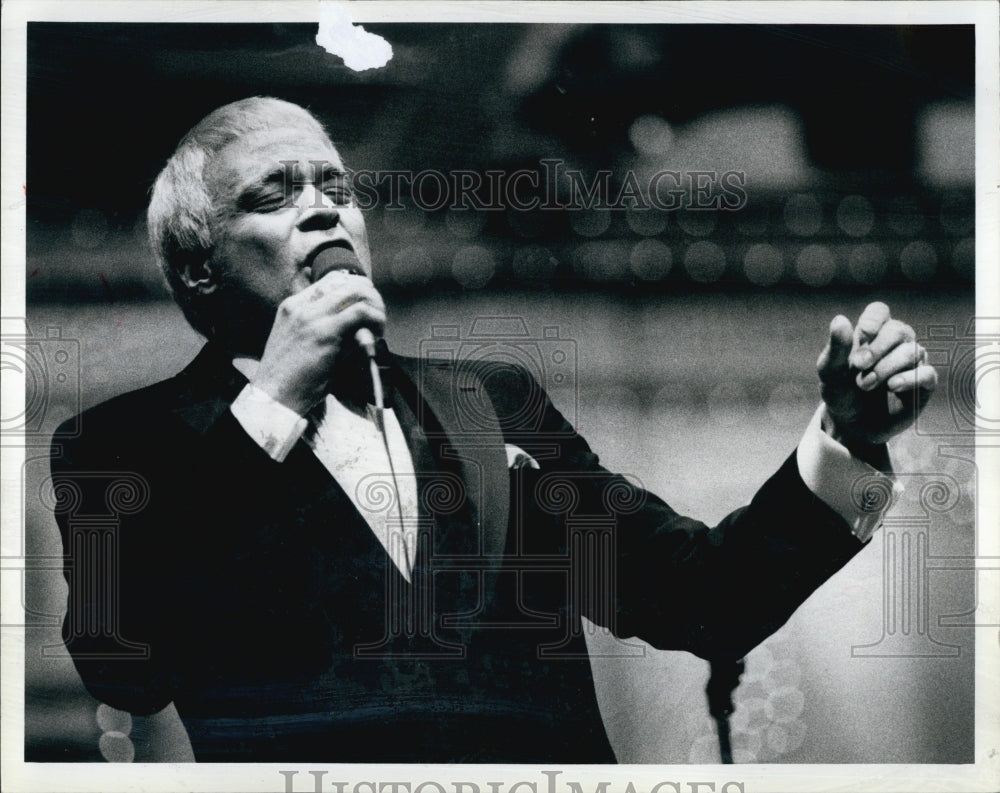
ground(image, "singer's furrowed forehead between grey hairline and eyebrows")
xmin=205 ymin=126 xmax=344 ymax=196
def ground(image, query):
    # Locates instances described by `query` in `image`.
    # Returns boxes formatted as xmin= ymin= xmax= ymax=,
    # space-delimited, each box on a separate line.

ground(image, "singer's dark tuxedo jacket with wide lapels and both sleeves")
xmin=52 ymin=344 xmax=861 ymax=762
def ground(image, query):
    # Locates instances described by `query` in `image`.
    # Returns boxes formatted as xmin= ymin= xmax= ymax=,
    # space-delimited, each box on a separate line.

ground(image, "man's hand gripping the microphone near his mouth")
xmin=253 ymin=270 xmax=385 ymax=416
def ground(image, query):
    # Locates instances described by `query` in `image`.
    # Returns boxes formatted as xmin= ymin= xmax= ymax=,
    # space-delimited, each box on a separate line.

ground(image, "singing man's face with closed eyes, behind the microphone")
xmin=206 ymin=120 xmax=372 ymax=335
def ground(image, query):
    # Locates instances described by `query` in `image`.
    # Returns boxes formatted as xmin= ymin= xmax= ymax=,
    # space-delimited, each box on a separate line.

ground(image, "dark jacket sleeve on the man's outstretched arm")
xmin=484 ymin=366 xmax=863 ymax=659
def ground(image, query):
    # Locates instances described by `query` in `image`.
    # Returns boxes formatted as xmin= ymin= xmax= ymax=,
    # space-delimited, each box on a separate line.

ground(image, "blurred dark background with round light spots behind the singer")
xmin=21 ymin=23 xmax=978 ymax=763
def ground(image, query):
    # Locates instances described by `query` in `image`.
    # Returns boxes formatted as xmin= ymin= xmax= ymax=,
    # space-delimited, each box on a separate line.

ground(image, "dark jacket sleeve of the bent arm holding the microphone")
xmin=50 ymin=400 xmax=290 ymax=715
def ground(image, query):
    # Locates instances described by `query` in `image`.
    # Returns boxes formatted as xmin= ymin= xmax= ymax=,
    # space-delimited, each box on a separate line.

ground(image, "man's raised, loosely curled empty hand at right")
xmin=816 ymin=303 xmax=937 ymax=451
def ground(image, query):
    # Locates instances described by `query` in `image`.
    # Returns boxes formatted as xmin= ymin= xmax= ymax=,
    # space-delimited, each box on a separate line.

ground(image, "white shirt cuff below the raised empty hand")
xmin=796 ymin=405 xmax=903 ymax=542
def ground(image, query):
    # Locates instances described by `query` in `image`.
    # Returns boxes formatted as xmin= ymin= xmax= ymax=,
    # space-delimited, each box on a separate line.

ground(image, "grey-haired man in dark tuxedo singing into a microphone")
xmin=52 ymin=98 xmax=936 ymax=763
